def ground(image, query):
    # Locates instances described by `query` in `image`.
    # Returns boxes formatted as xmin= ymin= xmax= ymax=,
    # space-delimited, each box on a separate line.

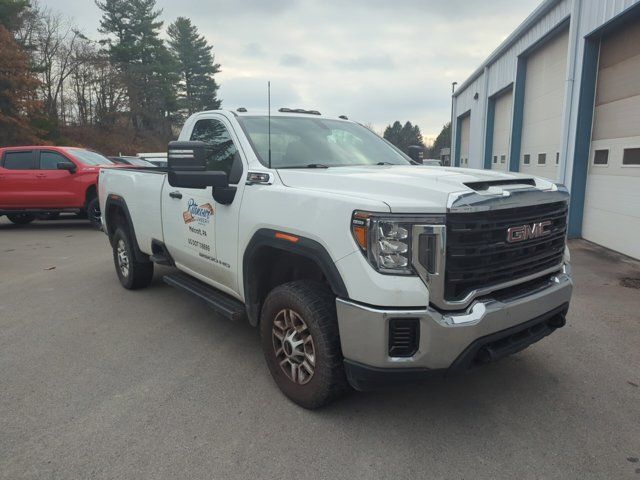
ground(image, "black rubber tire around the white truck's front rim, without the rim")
xmin=260 ymin=280 xmax=348 ymax=409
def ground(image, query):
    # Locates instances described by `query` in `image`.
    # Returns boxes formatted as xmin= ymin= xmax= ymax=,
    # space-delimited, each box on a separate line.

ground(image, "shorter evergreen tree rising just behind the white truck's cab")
xmin=167 ymin=17 xmax=221 ymax=115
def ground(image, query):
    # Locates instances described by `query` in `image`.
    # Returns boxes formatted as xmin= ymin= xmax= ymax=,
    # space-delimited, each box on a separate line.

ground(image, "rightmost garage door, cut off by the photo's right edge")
xmin=582 ymin=22 xmax=640 ymax=258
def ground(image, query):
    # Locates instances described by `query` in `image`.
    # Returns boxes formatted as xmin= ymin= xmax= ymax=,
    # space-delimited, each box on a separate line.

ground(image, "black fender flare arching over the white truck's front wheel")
xmin=242 ymin=228 xmax=349 ymax=326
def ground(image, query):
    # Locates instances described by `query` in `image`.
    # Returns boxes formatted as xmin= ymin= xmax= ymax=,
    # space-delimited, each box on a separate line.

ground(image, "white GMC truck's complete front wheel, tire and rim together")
xmin=260 ymin=281 xmax=348 ymax=409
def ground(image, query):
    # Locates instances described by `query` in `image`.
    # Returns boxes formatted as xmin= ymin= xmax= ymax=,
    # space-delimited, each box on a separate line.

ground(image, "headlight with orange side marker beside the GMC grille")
xmin=351 ymin=211 xmax=444 ymax=275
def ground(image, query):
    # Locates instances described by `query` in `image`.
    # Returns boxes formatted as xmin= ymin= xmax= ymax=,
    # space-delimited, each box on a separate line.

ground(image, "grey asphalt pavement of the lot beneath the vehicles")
xmin=0 ymin=218 xmax=640 ymax=480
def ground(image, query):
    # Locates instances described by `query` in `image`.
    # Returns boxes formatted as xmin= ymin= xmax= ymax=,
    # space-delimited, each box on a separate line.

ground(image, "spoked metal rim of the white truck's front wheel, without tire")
xmin=272 ymin=308 xmax=316 ymax=385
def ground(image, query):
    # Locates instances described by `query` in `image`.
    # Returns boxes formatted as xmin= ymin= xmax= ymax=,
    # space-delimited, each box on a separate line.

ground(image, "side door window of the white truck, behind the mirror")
xmin=191 ymin=119 xmax=238 ymax=182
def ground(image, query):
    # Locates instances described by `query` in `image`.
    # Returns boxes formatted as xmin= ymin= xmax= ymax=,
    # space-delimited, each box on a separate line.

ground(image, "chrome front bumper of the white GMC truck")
xmin=336 ymin=267 xmax=573 ymax=389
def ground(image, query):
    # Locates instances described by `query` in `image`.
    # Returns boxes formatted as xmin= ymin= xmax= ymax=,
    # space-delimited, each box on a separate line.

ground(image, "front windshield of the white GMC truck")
xmin=238 ymin=116 xmax=411 ymax=168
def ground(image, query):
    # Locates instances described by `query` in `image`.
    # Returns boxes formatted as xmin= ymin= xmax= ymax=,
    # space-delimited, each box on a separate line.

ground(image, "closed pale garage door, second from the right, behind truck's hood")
xmin=520 ymin=31 xmax=569 ymax=180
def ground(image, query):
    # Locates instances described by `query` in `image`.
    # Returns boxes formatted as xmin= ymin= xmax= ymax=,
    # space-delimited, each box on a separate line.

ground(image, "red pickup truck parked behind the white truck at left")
xmin=0 ymin=146 xmax=116 ymax=227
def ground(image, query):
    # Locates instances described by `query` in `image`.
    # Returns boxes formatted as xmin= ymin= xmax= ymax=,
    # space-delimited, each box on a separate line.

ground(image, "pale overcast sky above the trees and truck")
xmin=40 ymin=0 xmax=540 ymax=139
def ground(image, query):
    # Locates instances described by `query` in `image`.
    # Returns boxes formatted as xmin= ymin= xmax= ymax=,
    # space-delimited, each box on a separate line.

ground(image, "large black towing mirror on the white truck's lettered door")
xmin=167 ymin=142 xmax=229 ymax=188
